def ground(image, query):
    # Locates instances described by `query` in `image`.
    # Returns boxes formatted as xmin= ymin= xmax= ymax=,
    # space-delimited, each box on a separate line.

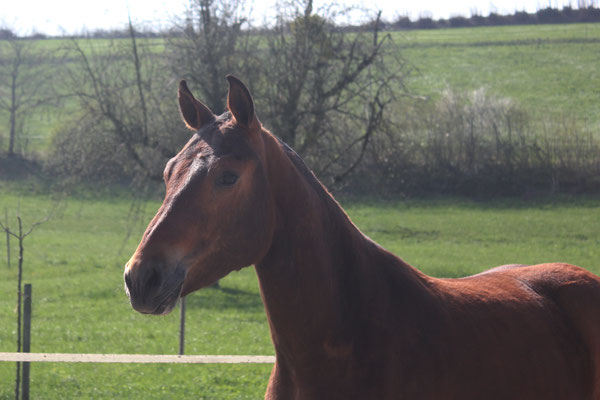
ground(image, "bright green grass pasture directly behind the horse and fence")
xmin=0 ymin=188 xmax=600 ymax=399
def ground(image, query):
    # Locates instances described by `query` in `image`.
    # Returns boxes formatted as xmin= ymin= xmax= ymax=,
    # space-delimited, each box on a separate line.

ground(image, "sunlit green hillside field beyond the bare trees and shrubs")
xmin=0 ymin=24 xmax=600 ymax=155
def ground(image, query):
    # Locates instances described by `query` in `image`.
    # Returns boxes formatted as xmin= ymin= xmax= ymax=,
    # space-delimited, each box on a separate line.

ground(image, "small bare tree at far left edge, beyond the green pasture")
xmin=0 ymin=38 xmax=56 ymax=156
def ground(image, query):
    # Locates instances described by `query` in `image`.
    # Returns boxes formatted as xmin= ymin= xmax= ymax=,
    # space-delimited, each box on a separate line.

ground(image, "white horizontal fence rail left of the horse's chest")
xmin=0 ymin=352 xmax=275 ymax=364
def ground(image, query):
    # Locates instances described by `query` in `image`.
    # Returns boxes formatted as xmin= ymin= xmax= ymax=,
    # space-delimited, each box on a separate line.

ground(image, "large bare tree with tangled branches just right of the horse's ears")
xmin=257 ymin=0 xmax=408 ymax=182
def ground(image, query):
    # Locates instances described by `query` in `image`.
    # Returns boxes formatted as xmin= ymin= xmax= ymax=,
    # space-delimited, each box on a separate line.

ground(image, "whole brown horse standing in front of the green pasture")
xmin=125 ymin=76 xmax=600 ymax=400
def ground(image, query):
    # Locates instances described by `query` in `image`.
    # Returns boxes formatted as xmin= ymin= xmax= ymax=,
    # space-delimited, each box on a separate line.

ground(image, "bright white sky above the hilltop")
xmin=0 ymin=0 xmax=577 ymax=35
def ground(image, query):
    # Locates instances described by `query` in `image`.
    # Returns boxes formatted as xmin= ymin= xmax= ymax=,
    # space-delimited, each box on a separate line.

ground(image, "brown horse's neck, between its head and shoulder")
xmin=256 ymin=132 xmax=432 ymax=357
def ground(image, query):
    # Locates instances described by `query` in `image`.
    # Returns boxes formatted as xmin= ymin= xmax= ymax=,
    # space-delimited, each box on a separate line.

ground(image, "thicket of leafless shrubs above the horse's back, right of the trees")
xmin=346 ymin=89 xmax=600 ymax=196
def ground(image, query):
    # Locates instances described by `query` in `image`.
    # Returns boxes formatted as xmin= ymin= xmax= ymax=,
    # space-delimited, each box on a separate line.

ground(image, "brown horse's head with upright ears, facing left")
xmin=124 ymin=75 xmax=274 ymax=314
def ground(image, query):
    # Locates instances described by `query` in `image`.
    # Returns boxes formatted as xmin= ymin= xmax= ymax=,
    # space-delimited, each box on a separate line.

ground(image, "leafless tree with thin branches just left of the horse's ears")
xmin=51 ymin=23 xmax=187 ymax=181
